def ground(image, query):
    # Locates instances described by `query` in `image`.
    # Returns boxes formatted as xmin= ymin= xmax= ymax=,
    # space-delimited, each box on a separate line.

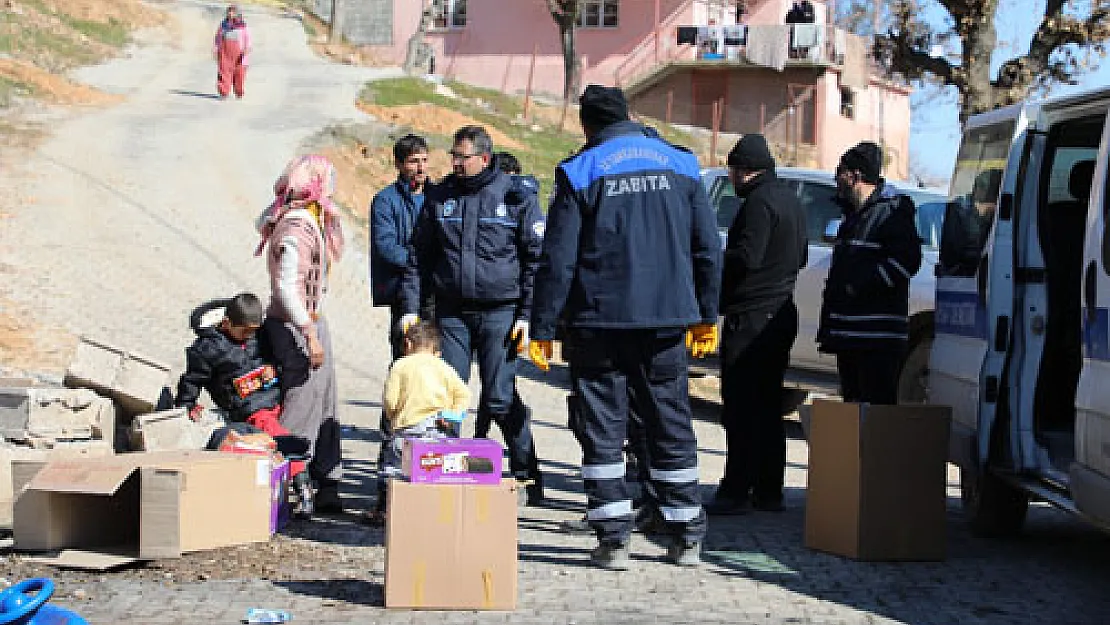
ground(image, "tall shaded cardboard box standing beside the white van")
xmin=806 ymin=401 xmax=951 ymax=561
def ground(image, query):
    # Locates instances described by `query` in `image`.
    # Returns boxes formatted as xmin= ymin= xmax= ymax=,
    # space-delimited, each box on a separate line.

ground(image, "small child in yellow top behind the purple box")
xmin=367 ymin=322 xmax=471 ymax=525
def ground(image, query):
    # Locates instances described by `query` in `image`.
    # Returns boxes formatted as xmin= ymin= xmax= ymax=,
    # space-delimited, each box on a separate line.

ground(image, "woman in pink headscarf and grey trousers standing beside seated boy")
xmin=254 ymin=155 xmax=343 ymax=512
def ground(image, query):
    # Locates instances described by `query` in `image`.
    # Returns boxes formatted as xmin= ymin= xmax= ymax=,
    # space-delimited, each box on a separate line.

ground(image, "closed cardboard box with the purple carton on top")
xmin=385 ymin=480 xmax=516 ymax=609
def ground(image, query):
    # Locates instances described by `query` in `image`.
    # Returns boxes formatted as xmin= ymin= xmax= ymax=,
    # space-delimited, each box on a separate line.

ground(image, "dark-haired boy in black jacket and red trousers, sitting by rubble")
xmin=174 ymin=293 xmax=312 ymax=516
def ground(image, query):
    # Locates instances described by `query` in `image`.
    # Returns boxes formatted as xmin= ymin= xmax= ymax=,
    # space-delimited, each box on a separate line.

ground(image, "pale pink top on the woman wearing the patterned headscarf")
xmin=266 ymin=209 xmax=327 ymax=329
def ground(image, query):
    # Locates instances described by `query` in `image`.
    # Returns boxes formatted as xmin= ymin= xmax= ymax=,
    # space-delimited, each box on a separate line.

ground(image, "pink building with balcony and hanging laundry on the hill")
xmin=355 ymin=0 xmax=910 ymax=179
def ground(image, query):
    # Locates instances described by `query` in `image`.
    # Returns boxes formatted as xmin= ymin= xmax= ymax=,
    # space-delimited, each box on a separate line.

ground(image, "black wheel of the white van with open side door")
xmin=960 ymin=468 xmax=1029 ymax=537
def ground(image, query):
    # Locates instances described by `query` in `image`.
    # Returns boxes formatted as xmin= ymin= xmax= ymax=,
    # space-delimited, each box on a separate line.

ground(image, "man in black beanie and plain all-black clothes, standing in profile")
xmin=706 ymin=134 xmax=808 ymax=515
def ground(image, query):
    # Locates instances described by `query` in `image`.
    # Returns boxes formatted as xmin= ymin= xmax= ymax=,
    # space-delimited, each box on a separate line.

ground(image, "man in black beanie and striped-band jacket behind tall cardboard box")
xmin=817 ymin=141 xmax=921 ymax=404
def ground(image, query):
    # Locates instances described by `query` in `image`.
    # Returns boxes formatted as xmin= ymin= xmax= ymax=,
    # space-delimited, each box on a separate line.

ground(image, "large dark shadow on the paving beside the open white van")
xmin=703 ymin=487 xmax=1110 ymax=625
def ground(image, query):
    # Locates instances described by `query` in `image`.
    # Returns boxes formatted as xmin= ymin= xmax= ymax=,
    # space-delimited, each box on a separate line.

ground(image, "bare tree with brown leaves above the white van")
xmin=875 ymin=0 xmax=1110 ymax=122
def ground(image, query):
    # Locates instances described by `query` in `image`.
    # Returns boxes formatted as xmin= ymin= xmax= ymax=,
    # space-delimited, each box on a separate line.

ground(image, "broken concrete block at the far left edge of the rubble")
xmin=0 ymin=387 xmax=115 ymax=446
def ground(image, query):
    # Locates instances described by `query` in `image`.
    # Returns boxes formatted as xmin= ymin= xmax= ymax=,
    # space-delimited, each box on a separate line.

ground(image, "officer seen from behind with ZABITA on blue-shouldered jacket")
xmin=529 ymin=84 xmax=720 ymax=569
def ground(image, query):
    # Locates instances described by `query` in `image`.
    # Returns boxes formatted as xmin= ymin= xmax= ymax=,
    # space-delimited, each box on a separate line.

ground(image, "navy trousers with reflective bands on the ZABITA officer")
xmin=565 ymin=329 xmax=706 ymax=543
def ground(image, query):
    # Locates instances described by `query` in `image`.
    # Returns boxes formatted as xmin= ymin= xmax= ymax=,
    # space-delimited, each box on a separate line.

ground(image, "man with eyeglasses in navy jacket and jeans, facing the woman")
xmin=400 ymin=125 xmax=544 ymax=505
